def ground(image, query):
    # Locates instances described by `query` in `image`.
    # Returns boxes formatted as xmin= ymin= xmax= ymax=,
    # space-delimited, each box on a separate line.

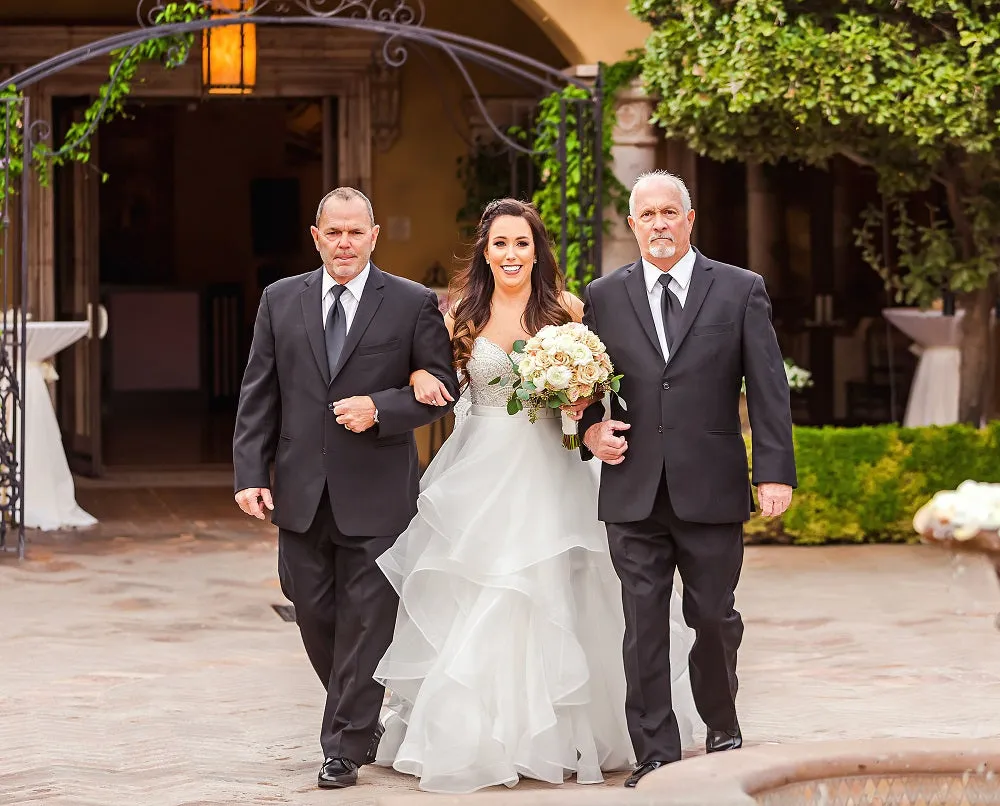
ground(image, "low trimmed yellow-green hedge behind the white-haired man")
xmin=746 ymin=422 xmax=1000 ymax=545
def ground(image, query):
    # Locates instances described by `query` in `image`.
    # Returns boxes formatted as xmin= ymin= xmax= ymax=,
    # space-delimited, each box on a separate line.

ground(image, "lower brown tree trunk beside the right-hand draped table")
xmin=958 ymin=280 xmax=996 ymax=427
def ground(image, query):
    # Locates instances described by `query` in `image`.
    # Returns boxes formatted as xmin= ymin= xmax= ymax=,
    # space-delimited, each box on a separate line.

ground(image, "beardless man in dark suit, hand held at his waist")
xmin=233 ymin=188 xmax=458 ymax=788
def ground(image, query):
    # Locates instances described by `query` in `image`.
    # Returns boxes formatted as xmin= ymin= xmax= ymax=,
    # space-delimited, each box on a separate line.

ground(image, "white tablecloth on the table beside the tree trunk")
xmin=882 ymin=308 xmax=965 ymax=427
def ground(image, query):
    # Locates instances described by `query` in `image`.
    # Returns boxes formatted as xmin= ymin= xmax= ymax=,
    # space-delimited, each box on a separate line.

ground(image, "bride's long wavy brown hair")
xmin=449 ymin=199 xmax=572 ymax=384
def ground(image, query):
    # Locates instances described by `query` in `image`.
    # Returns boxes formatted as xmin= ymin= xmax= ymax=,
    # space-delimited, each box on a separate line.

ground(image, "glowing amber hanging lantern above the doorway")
xmin=201 ymin=0 xmax=257 ymax=95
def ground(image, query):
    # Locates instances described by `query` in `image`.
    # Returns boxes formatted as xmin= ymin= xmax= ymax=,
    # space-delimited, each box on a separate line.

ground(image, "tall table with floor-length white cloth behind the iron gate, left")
xmin=6 ymin=322 xmax=97 ymax=530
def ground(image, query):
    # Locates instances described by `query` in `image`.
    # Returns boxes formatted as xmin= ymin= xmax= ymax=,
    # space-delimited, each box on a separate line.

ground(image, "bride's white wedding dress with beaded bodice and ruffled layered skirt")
xmin=375 ymin=337 xmax=703 ymax=793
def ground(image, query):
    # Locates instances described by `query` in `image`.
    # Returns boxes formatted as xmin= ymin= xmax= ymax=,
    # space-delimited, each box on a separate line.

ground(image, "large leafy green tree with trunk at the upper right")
xmin=631 ymin=0 xmax=1000 ymax=424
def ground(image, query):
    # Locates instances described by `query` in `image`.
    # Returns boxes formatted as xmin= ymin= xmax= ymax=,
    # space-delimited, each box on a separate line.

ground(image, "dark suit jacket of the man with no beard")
xmin=233 ymin=265 xmax=458 ymax=537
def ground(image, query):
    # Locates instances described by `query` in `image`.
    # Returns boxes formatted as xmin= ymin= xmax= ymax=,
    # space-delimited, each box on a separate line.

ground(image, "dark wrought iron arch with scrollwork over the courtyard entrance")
xmin=0 ymin=0 xmax=603 ymax=557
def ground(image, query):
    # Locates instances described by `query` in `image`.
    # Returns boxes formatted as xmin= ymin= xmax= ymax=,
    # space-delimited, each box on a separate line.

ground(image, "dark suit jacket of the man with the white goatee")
xmin=580 ymin=250 xmax=796 ymax=523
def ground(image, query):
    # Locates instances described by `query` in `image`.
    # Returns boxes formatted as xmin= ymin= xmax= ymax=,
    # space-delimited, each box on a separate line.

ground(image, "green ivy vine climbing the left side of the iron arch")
xmin=0 ymin=2 xmax=207 ymax=215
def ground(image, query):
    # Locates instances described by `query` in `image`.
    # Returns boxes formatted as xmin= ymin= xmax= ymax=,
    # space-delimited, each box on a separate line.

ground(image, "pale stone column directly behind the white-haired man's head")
xmin=601 ymin=80 xmax=658 ymax=274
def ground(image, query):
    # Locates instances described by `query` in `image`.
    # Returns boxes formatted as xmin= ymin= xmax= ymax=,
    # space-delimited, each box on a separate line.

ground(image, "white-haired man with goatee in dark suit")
xmin=581 ymin=172 xmax=796 ymax=787
